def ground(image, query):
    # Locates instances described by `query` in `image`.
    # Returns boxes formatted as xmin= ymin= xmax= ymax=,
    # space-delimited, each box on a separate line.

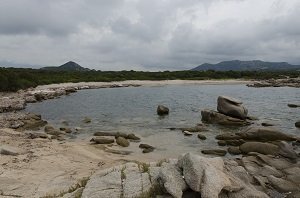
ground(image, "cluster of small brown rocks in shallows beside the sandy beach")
xmin=90 ymin=132 xmax=155 ymax=155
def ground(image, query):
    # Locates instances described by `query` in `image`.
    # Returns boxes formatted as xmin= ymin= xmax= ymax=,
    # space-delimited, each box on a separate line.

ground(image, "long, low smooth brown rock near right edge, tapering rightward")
xmin=236 ymin=127 xmax=296 ymax=142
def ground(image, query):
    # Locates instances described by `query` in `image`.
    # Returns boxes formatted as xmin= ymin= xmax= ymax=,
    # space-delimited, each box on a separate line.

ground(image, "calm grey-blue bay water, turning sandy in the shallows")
xmin=26 ymin=85 xmax=300 ymax=157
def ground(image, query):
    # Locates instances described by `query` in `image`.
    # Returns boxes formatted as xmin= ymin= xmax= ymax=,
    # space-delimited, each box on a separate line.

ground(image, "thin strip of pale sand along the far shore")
xmin=36 ymin=79 xmax=253 ymax=90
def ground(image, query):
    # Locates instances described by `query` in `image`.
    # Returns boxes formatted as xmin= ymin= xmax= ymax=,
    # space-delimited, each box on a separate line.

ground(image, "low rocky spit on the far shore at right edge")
xmin=247 ymin=78 xmax=300 ymax=88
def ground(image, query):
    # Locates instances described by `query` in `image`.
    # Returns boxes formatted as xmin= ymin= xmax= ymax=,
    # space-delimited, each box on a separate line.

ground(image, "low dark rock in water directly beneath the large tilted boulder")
xmin=201 ymin=110 xmax=251 ymax=126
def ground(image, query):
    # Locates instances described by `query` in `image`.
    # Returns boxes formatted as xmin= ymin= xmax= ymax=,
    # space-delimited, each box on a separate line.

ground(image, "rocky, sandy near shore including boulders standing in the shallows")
xmin=0 ymin=81 xmax=300 ymax=198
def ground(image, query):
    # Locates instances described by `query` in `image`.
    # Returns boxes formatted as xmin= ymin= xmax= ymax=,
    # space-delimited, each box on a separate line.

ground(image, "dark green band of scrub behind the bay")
xmin=0 ymin=68 xmax=300 ymax=91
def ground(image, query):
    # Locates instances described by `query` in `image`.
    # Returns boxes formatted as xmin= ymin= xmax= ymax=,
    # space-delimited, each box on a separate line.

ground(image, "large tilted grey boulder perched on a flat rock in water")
xmin=217 ymin=96 xmax=248 ymax=120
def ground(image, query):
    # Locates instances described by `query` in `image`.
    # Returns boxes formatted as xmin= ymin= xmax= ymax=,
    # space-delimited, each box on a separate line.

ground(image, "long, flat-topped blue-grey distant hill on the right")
xmin=191 ymin=60 xmax=300 ymax=71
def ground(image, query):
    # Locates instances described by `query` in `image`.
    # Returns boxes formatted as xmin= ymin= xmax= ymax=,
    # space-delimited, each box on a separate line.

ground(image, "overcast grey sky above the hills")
xmin=0 ymin=0 xmax=300 ymax=71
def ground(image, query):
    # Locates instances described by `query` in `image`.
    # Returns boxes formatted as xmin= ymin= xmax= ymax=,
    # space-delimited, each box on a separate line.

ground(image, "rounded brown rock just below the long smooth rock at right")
xmin=240 ymin=142 xmax=279 ymax=155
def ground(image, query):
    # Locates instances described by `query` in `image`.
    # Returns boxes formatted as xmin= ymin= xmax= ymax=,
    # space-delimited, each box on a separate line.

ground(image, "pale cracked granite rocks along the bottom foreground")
xmin=82 ymin=153 xmax=300 ymax=198
